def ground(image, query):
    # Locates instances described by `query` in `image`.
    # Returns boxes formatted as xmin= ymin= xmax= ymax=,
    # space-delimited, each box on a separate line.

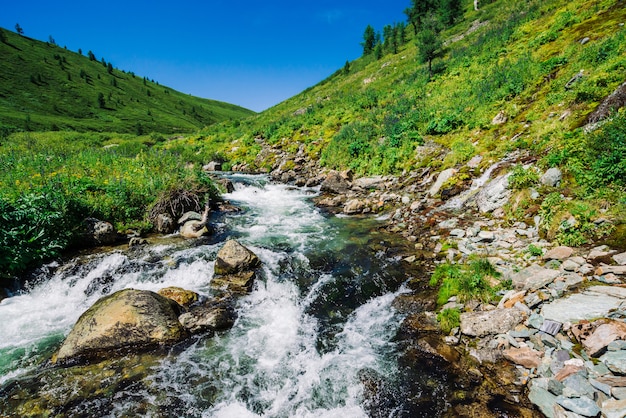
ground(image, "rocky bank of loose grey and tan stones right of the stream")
xmin=260 ymin=144 xmax=626 ymax=418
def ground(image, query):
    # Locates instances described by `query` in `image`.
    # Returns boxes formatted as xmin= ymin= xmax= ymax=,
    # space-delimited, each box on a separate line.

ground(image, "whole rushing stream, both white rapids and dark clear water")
xmin=0 ymin=175 xmax=426 ymax=418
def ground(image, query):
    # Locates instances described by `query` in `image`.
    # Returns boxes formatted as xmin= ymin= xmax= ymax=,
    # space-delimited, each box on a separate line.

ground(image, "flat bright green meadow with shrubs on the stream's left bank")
xmin=0 ymin=132 xmax=217 ymax=279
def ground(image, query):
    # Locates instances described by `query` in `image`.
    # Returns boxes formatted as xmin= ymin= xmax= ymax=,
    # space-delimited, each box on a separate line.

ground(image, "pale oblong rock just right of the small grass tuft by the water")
xmin=461 ymin=308 xmax=525 ymax=337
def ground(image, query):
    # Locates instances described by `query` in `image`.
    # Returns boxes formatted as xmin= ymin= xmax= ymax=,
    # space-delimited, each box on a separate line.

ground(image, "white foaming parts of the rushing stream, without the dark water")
xmin=0 ymin=176 xmax=399 ymax=418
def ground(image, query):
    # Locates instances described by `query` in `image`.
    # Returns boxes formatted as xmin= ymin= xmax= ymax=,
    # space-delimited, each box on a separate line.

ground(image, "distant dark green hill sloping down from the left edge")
xmin=0 ymin=29 xmax=254 ymax=133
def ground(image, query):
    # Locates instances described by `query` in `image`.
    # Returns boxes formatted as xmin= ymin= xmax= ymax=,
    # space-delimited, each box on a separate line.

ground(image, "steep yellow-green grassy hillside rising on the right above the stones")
xmin=179 ymin=0 xmax=626 ymax=240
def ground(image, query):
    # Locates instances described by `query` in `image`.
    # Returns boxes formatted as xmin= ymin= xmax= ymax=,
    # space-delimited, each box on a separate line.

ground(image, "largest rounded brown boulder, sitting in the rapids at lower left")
xmin=53 ymin=289 xmax=187 ymax=363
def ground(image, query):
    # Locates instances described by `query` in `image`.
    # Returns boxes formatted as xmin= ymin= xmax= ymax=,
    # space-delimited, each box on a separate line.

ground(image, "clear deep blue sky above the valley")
xmin=0 ymin=0 xmax=410 ymax=111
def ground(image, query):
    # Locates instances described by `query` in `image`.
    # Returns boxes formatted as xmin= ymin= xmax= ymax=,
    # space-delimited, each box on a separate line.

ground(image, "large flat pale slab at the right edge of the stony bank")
xmin=541 ymin=286 xmax=626 ymax=323
